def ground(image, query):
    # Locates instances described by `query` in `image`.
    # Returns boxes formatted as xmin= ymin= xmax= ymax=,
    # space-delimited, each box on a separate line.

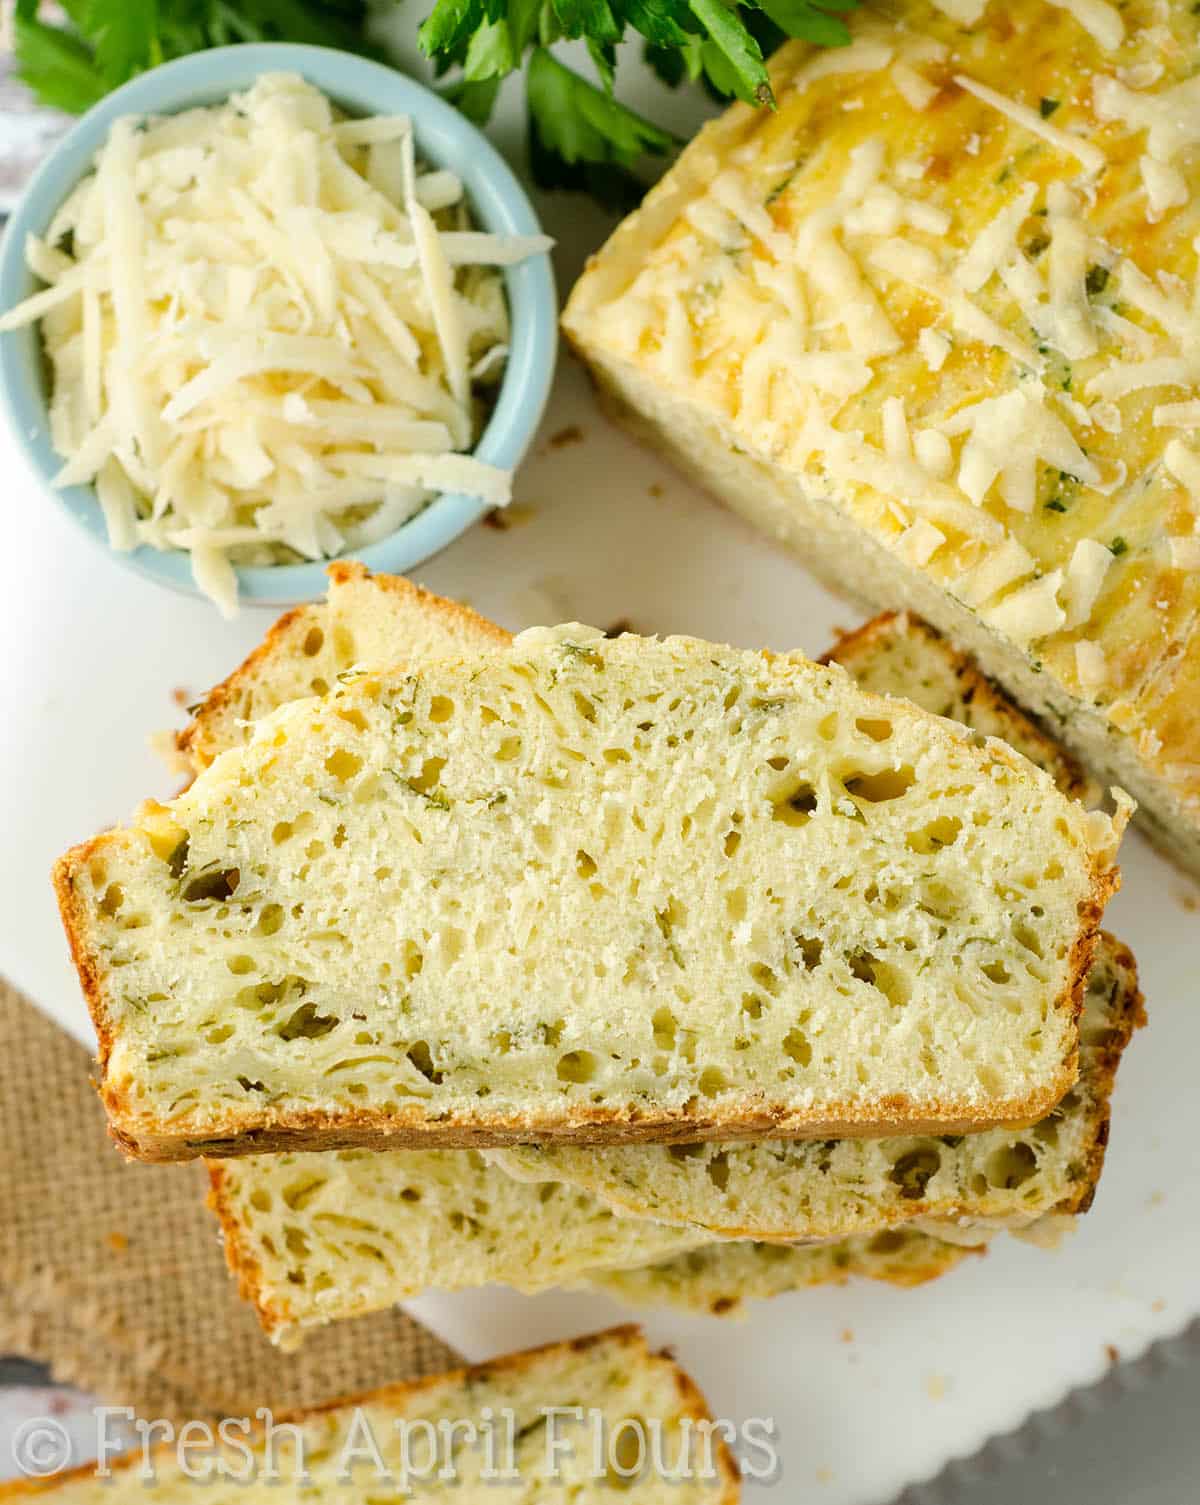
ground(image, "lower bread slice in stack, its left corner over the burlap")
xmin=208 ymin=1150 xmax=708 ymax=1348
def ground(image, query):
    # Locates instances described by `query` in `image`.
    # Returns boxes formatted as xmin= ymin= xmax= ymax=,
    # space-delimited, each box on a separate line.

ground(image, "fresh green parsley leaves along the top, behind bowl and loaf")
xmin=14 ymin=0 xmax=858 ymax=208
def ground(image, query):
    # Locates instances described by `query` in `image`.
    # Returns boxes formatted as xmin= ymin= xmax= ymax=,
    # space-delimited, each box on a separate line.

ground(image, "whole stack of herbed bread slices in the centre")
xmin=56 ymin=564 xmax=1143 ymax=1342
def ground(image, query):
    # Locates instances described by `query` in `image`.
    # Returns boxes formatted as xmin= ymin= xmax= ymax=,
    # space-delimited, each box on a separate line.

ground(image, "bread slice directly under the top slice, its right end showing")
xmin=495 ymin=936 xmax=1143 ymax=1263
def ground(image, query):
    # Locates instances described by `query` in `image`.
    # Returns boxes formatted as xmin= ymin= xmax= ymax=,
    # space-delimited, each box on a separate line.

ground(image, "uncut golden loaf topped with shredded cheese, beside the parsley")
xmin=563 ymin=0 xmax=1200 ymax=873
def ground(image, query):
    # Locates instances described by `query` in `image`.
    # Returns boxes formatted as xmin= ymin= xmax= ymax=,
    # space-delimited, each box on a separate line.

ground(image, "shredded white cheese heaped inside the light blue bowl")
xmin=0 ymin=74 xmax=551 ymax=614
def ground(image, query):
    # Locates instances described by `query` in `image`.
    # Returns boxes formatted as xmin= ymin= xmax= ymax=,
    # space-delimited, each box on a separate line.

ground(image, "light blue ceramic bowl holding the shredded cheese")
xmin=0 ymin=42 xmax=557 ymax=605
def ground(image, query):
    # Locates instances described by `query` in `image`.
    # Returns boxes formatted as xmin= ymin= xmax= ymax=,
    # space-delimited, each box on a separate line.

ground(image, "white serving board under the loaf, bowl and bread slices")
xmin=0 ymin=35 xmax=1200 ymax=1505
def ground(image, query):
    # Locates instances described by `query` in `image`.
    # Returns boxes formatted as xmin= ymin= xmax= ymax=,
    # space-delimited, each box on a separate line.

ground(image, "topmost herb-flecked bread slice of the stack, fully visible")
xmin=57 ymin=626 xmax=1120 ymax=1159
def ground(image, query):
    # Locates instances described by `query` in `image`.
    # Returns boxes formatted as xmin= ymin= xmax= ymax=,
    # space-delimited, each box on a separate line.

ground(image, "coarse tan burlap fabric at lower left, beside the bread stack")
xmin=0 ymin=981 xmax=456 ymax=1422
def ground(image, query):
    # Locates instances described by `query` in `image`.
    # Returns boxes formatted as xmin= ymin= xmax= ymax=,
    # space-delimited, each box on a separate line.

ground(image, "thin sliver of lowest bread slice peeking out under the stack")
xmin=587 ymin=1228 xmax=985 ymax=1317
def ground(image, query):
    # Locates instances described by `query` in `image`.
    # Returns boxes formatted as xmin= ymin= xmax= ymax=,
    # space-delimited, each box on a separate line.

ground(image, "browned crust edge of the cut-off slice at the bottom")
xmin=0 ymin=1323 xmax=741 ymax=1505
